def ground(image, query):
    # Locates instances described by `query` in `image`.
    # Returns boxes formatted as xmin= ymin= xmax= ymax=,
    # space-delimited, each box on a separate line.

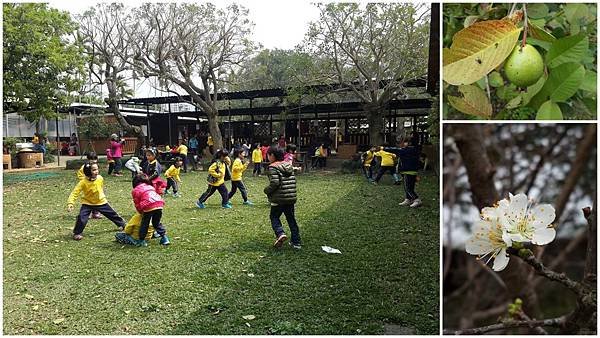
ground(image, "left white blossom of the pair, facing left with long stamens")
xmin=466 ymin=208 xmax=512 ymax=271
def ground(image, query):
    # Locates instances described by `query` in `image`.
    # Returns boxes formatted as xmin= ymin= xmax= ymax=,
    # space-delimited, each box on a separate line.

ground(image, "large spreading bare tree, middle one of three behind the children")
xmin=129 ymin=3 xmax=253 ymax=148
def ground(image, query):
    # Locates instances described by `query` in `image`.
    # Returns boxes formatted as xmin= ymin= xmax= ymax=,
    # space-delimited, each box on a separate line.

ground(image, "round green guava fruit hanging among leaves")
xmin=504 ymin=44 xmax=544 ymax=88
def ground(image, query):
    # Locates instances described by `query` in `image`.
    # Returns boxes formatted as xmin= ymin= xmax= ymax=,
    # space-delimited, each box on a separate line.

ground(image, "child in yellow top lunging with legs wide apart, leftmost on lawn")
xmin=67 ymin=163 xmax=125 ymax=241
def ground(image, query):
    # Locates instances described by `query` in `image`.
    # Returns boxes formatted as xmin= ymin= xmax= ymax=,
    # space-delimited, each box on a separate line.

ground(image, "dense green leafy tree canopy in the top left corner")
xmin=3 ymin=3 xmax=84 ymax=122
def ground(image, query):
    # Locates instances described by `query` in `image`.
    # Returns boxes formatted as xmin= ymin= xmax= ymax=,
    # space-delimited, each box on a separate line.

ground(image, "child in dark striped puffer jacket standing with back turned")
xmin=264 ymin=147 xmax=301 ymax=249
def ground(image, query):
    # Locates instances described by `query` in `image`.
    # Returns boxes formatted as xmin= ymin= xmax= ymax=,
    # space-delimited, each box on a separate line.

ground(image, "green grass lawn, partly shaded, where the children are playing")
xmin=3 ymin=168 xmax=439 ymax=335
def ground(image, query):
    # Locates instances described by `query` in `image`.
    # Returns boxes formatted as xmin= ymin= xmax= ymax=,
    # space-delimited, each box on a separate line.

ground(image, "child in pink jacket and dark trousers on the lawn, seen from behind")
xmin=131 ymin=174 xmax=169 ymax=246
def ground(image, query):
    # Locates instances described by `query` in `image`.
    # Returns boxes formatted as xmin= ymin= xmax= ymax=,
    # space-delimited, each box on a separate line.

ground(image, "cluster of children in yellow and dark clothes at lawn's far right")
xmin=361 ymin=140 xmax=422 ymax=208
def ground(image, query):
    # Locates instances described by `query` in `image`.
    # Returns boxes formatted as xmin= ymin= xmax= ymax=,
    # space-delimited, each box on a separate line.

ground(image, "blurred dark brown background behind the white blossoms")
xmin=443 ymin=124 xmax=597 ymax=334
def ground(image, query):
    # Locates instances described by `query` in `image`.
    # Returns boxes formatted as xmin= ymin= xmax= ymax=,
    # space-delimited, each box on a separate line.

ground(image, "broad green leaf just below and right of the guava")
xmin=530 ymin=63 xmax=585 ymax=109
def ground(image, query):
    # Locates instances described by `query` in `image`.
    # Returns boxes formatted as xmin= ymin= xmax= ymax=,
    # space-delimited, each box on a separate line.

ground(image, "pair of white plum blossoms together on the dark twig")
xmin=466 ymin=194 xmax=556 ymax=271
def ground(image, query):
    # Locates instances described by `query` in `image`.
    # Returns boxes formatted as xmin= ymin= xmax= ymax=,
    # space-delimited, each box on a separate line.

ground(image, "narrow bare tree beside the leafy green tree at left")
xmin=77 ymin=3 xmax=144 ymax=145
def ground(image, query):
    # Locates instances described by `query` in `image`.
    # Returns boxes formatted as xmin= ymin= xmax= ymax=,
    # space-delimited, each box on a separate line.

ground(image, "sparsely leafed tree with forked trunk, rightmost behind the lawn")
xmin=305 ymin=3 xmax=429 ymax=144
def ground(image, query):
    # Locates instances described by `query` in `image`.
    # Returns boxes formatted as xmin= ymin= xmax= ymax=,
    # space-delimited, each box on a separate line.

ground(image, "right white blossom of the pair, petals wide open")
xmin=498 ymin=194 xmax=556 ymax=245
